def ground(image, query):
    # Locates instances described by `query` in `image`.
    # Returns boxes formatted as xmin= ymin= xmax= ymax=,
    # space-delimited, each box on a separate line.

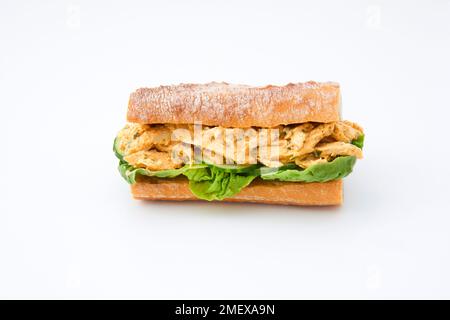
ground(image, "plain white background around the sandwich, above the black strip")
xmin=0 ymin=0 xmax=450 ymax=299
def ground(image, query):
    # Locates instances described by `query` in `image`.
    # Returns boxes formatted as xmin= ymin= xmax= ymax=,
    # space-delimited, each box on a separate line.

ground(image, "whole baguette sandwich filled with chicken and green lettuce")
xmin=114 ymin=82 xmax=364 ymax=205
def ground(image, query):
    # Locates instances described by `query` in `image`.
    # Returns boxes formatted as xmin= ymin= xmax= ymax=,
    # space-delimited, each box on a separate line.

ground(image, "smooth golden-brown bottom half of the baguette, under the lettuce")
xmin=131 ymin=177 xmax=343 ymax=206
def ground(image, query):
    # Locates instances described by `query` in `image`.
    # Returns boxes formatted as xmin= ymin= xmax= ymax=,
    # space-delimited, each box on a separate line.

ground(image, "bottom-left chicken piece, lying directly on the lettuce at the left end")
xmin=124 ymin=150 xmax=182 ymax=171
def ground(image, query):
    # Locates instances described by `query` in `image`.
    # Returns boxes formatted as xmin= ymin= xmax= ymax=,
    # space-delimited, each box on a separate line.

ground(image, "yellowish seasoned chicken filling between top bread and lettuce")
xmin=116 ymin=121 xmax=363 ymax=170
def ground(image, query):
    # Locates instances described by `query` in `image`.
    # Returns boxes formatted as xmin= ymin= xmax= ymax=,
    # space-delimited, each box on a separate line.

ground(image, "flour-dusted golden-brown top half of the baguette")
xmin=127 ymin=82 xmax=340 ymax=128
